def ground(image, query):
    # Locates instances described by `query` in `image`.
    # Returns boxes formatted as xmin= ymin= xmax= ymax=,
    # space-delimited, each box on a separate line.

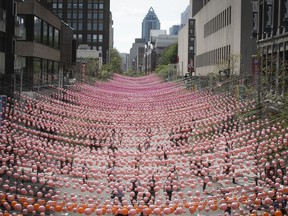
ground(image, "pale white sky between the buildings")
xmin=110 ymin=0 xmax=189 ymax=53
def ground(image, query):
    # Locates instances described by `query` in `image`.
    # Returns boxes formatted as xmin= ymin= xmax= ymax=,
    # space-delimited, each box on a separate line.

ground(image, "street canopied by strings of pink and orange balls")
xmin=0 ymin=74 xmax=288 ymax=216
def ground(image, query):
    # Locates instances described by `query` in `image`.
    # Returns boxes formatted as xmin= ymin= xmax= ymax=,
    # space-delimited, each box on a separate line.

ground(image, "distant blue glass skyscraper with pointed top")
xmin=142 ymin=7 xmax=160 ymax=43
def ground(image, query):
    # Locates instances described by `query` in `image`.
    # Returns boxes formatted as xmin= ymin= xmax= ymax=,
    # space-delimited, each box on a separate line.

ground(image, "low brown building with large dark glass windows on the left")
xmin=15 ymin=0 xmax=76 ymax=91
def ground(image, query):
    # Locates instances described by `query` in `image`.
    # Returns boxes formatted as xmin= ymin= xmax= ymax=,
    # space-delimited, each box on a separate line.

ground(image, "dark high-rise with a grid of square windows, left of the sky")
xmin=44 ymin=0 xmax=113 ymax=64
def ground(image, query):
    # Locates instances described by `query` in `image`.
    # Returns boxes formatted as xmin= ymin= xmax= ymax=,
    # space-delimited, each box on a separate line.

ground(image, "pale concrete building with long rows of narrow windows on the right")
xmin=193 ymin=0 xmax=256 ymax=76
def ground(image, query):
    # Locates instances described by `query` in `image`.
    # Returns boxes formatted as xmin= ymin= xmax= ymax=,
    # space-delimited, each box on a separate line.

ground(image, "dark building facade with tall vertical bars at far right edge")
xmin=254 ymin=0 xmax=288 ymax=95
